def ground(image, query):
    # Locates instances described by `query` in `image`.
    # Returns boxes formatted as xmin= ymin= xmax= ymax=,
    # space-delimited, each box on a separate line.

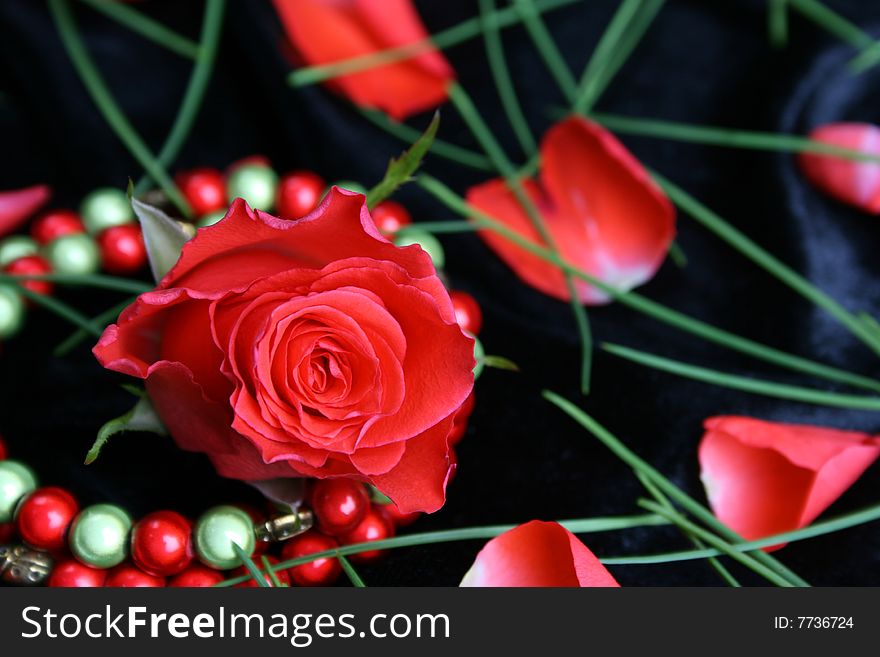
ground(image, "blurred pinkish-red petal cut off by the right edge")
xmin=798 ymin=123 xmax=880 ymax=214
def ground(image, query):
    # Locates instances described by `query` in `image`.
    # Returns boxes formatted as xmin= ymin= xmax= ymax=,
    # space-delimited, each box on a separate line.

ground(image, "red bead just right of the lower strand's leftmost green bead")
xmin=15 ymin=486 xmax=79 ymax=552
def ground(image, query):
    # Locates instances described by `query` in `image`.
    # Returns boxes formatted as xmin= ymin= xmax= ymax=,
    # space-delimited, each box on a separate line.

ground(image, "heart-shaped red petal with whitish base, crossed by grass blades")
xmin=467 ymin=118 xmax=675 ymax=304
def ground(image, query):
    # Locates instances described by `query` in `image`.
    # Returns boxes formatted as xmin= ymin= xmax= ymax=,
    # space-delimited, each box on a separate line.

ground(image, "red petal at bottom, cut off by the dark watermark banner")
xmin=461 ymin=520 xmax=620 ymax=587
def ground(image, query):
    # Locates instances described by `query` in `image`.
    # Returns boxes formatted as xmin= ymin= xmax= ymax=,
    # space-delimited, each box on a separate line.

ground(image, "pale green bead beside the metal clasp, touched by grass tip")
xmin=193 ymin=506 xmax=256 ymax=570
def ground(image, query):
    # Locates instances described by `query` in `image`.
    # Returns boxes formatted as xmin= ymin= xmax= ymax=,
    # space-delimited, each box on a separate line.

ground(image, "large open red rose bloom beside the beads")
xmin=94 ymin=188 xmax=474 ymax=511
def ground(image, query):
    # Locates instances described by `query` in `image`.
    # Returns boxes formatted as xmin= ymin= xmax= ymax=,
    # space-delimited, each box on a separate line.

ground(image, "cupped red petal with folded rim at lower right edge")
xmin=699 ymin=416 xmax=880 ymax=547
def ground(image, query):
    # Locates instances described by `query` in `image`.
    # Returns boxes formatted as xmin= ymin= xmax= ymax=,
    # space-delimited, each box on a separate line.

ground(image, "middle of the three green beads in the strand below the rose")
xmin=68 ymin=504 xmax=131 ymax=568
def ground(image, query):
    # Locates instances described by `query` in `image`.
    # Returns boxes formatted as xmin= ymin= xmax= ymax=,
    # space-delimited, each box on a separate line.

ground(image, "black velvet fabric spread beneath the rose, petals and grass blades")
xmin=0 ymin=0 xmax=880 ymax=586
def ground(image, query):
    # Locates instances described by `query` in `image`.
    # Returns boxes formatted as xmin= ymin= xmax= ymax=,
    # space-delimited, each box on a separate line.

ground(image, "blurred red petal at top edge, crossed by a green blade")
xmin=273 ymin=0 xmax=455 ymax=120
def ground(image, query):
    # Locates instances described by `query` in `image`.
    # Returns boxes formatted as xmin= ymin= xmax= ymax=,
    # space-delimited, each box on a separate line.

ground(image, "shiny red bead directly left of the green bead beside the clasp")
xmin=131 ymin=511 xmax=193 ymax=577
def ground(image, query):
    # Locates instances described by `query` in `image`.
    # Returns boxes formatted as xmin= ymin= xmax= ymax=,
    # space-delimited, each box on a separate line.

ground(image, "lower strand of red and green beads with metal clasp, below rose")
xmin=0 ymin=430 xmax=454 ymax=587
